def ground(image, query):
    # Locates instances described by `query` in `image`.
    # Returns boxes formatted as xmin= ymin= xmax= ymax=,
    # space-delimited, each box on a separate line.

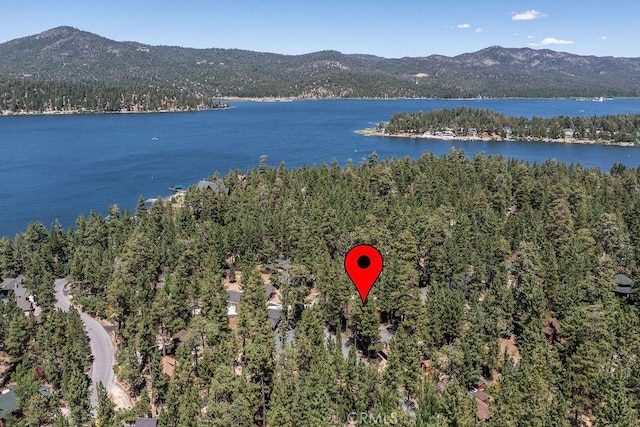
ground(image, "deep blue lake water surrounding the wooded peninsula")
xmin=0 ymin=99 xmax=640 ymax=237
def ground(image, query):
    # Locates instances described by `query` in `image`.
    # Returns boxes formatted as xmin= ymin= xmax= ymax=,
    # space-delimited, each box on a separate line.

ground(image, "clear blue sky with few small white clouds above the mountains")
xmin=0 ymin=0 xmax=640 ymax=58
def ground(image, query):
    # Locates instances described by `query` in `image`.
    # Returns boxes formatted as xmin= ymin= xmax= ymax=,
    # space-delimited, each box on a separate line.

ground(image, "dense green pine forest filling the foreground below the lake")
xmin=0 ymin=151 xmax=640 ymax=427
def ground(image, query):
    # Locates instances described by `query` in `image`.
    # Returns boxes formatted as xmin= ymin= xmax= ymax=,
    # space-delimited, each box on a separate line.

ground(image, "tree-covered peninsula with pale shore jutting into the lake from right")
xmin=359 ymin=107 xmax=640 ymax=147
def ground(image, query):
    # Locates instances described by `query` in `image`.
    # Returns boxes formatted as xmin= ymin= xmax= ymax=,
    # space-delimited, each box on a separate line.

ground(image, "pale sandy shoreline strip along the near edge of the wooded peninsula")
xmin=356 ymin=128 xmax=637 ymax=147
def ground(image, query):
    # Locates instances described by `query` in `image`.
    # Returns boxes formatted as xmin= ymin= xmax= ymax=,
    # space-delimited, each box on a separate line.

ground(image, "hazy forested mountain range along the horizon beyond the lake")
xmin=0 ymin=27 xmax=640 ymax=98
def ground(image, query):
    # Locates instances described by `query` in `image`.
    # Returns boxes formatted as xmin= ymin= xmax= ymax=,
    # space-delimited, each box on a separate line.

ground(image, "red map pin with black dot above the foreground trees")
xmin=344 ymin=245 xmax=382 ymax=304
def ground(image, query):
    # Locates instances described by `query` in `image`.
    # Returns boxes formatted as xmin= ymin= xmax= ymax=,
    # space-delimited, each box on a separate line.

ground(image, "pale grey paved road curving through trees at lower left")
xmin=56 ymin=279 xmax=115 ymax=407
